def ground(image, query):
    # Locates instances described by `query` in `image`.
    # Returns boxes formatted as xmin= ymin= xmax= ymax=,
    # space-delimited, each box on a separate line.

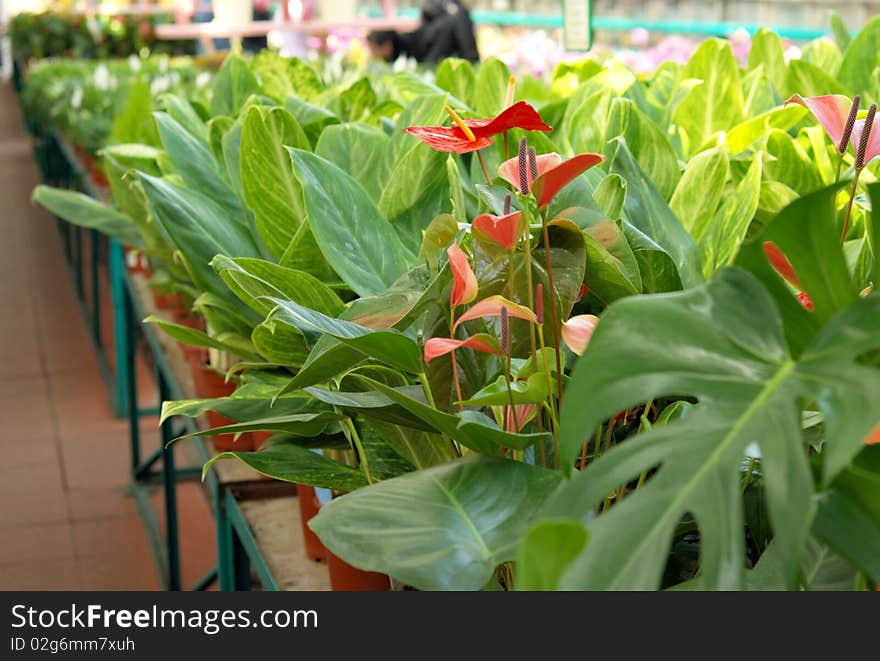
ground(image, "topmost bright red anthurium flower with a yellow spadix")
xmin=403 ymin=101 xmax=553 ymax=154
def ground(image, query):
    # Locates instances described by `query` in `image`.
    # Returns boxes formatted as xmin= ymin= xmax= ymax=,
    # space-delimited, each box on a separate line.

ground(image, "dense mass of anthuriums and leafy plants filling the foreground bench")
xmin=35 ymin=21 xmax=880 ymax=589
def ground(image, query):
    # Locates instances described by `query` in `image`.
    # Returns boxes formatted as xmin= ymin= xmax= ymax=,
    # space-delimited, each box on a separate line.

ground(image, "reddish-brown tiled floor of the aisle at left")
xmin=0 ymin=83 xmax=216 ymax=590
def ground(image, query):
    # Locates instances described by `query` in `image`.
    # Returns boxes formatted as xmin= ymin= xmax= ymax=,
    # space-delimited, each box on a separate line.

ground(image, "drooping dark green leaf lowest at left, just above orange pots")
xmin=204 ymin=440 xmax=368 ymax=491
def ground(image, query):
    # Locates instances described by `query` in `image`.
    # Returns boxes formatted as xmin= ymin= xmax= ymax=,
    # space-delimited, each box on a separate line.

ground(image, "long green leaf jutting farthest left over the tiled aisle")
xmin=31 ymin=184 xmax=145 ymax=248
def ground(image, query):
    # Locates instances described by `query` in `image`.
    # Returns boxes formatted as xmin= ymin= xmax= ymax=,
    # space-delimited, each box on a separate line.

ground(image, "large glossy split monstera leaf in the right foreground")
xmin=547 ymin=268 xmax=880 ymax=589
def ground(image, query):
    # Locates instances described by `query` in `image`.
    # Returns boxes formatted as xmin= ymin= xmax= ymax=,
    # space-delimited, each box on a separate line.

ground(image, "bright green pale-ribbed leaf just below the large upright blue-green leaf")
xmin=211 ymin=255 xmax=345 ymax=317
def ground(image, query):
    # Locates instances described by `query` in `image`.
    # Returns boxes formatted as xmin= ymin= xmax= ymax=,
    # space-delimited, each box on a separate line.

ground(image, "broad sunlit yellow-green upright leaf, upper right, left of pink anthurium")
xmin=675 ymin=39 xmax=743 ymax=153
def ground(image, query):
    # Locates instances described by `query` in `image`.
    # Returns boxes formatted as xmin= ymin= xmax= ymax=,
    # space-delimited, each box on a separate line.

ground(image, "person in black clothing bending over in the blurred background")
xmin=367 ymin=0 xmax=480 ymax=63
